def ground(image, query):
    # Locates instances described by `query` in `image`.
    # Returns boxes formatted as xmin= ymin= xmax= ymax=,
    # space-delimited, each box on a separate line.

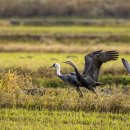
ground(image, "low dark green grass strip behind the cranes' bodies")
xmin=33 ymin=75 xmax=130 ymax=88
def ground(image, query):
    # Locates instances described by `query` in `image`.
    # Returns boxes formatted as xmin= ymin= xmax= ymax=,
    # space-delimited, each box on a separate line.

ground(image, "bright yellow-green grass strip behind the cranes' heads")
xmin=0 ymin=52 xmax=127 ymax=71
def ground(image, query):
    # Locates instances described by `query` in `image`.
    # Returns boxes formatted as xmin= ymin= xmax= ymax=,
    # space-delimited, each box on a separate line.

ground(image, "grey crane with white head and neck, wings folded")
xmin=49 ymin=63 xmax=83 ymax=97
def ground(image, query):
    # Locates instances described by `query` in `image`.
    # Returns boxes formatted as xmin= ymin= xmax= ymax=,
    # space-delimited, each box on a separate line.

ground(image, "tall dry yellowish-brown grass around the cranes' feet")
xmin=0 ymin=72 xmax=130 ymax=113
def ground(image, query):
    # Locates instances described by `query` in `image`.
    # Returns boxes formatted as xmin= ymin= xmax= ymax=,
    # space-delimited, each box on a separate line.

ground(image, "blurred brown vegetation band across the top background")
xmin=0 ymin=0 xmax=130 ymax=18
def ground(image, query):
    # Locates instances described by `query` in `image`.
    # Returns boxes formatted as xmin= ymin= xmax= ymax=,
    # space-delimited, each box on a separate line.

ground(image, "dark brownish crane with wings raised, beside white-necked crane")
xmin=64 ymin=50 xmax=119 ymax=96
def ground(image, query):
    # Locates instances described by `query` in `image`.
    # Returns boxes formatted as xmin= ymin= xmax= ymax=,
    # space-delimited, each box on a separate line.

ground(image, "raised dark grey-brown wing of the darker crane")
xmin=83 ymin=51 xmax=119 ymax=81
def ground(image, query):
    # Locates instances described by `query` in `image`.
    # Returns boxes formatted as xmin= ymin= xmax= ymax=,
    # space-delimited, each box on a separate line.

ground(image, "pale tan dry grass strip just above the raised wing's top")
xmin=0 ymin=41 xmax=130 ymax=54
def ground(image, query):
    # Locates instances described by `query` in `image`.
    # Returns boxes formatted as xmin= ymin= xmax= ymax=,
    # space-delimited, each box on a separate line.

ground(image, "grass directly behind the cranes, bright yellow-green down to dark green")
xmin=0 ymin=52 xmax=130 ymax=87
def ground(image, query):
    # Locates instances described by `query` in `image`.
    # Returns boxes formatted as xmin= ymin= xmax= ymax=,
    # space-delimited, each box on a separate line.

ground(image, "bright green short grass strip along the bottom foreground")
xmin=0 ymin=109 xmax=130 ymax=130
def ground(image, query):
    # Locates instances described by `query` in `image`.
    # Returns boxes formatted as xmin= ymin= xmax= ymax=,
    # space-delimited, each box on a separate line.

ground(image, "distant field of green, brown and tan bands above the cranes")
xmin=0 ymin=26 xmax=130 ymax=54
